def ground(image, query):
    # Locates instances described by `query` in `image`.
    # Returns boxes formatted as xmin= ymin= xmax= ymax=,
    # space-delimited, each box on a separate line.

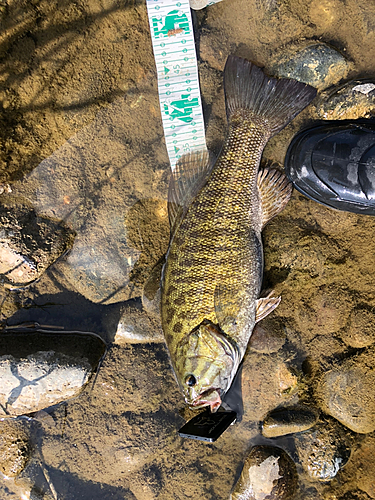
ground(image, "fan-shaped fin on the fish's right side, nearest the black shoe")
xmin=258 ymin=167 xmax=293 ymax=228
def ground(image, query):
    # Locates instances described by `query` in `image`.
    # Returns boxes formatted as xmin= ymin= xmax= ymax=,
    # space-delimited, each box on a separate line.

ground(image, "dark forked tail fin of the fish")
xmin=224 ymin=56 xmax=316 ymax=136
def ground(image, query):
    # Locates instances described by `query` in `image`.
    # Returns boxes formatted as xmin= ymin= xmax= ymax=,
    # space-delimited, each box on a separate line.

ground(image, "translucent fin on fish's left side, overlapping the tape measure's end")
xmin=168 ymin=150 xmax=215 ymax=232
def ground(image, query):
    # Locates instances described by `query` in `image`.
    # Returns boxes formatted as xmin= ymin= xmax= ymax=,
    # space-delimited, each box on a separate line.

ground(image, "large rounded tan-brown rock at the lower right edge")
xmin=316 ymin=349 xmax=375 ymax=434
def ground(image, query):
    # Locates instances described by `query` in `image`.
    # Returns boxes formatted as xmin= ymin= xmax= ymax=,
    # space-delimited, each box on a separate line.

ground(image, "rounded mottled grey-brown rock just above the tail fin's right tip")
xmin=268 ymin=41 xmax=351 ymax=90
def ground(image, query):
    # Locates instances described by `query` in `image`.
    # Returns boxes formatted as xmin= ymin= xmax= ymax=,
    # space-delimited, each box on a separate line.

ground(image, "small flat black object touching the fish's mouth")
xmin=178 ymin=408 xmax=236 ymax=443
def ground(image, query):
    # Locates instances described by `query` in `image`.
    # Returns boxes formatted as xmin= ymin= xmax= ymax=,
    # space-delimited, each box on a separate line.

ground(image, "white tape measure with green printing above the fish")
xmin=146 ymin=0 xmax=206 ymax=170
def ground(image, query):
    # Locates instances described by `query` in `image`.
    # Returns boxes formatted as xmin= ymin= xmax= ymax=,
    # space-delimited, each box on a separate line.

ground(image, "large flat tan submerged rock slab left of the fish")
xmin=3 ymin=93 xmax=169 ymax=304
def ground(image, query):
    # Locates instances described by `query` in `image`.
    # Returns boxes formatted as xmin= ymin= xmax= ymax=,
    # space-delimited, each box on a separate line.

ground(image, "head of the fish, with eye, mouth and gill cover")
xmin=176 ymin=320 xmax=240 ymax=410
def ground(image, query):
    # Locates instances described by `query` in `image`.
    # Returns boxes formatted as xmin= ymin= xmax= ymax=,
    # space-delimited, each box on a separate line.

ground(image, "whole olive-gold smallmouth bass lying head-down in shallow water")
xmin=161 ymin=56 xmax=316 ymax=411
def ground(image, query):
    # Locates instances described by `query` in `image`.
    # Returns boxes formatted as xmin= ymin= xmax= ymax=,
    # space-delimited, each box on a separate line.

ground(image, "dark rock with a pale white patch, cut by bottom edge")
xmin=230 ymin=446 xmax=297 ymax=500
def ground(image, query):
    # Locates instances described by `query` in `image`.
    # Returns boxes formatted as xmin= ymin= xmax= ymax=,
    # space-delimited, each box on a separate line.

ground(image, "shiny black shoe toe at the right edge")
xmin=285 ymin=121 xmax=375 ymax=215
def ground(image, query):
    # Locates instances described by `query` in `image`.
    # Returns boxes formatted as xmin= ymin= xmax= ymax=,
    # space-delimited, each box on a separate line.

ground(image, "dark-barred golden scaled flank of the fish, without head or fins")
xmin=164 ymin=117 xmax=269 ymax=356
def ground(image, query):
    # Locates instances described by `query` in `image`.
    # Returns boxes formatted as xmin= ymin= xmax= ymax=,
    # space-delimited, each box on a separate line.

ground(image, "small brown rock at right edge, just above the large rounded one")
xmin=341 ymin=309 xmax=375 ymax=348
